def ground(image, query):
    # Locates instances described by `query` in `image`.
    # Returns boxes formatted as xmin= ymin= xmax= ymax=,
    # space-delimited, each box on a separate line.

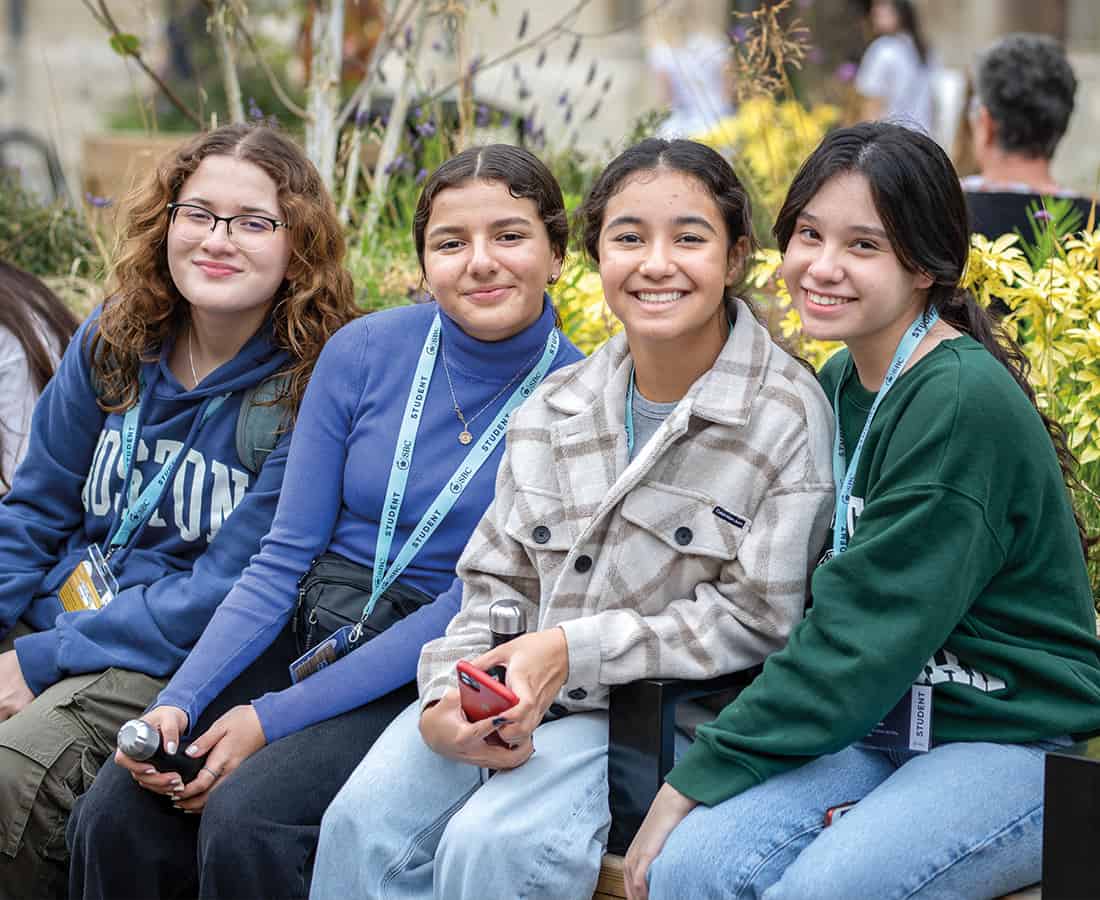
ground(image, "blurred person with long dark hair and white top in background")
xmin=856 ymin=0 xmax=933 ymax=133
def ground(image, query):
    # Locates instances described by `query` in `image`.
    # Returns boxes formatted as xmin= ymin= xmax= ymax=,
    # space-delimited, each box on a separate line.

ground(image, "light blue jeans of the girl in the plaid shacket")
xmin=309 ymin=703 xmax=611 ymax=900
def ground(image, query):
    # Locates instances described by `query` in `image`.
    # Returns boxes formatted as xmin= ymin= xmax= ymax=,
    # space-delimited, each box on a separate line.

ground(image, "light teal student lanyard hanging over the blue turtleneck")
xmin=361 ymin=312 xmax=560 ymax=622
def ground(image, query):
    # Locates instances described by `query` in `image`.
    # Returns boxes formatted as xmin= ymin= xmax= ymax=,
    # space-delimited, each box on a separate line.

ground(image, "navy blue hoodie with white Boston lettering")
xmin=0 ymin=311 xmax=289 ymax=694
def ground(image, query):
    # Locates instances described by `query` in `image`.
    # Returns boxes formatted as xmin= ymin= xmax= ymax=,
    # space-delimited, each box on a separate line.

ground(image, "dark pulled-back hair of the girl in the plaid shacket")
xmin=575 ymin=138 xmax=756 ymax=319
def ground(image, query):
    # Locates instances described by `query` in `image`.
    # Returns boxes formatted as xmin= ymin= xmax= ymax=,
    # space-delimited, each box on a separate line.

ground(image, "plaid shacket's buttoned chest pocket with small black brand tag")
xmin=620 ymin=482 xmax=752 ymax=586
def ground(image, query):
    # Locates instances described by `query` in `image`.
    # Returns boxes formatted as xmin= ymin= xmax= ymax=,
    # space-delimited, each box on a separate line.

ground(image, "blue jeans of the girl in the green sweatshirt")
xmin=649 ymin=739 xmax=1069 ymax=900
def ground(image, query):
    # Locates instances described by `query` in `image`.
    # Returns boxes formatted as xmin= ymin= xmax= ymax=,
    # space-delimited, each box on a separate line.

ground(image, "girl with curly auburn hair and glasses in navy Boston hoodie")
xmin=0 ymin=125 xmax=355 ymax=898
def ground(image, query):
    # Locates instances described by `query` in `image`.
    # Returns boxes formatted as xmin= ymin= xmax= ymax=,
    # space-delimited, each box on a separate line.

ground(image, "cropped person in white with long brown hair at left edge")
xmin=0 ymin=260 xmax=79 ymax=495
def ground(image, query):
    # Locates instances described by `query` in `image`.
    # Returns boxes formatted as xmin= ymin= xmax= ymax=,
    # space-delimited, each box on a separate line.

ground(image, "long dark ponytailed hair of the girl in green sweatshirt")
xmin=774 ymin=122 xmax=1096 ymax=557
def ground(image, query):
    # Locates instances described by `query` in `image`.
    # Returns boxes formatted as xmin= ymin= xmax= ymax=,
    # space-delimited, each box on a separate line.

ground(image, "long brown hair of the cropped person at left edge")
xmin=0 ymin=261 xmax=79 ymax=491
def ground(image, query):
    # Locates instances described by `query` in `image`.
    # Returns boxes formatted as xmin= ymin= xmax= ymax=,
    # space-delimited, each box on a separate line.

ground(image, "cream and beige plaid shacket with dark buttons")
xmin=418 ymin=304 xmax=833 ymax=711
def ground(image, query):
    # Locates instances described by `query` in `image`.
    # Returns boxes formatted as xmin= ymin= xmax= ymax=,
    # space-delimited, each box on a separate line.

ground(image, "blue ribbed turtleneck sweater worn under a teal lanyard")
xmin=157 ymin=303 xmax=581 ymax=740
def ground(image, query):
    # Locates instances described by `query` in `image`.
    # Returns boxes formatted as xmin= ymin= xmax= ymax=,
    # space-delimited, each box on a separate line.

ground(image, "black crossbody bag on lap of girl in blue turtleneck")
xmin=292 ymin=552 xmax=435 ymax=654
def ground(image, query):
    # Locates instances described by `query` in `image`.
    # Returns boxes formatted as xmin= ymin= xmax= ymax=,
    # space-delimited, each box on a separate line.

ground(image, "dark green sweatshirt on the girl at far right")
xmin=668 ymin=337 xmax=1100 ymax=804
